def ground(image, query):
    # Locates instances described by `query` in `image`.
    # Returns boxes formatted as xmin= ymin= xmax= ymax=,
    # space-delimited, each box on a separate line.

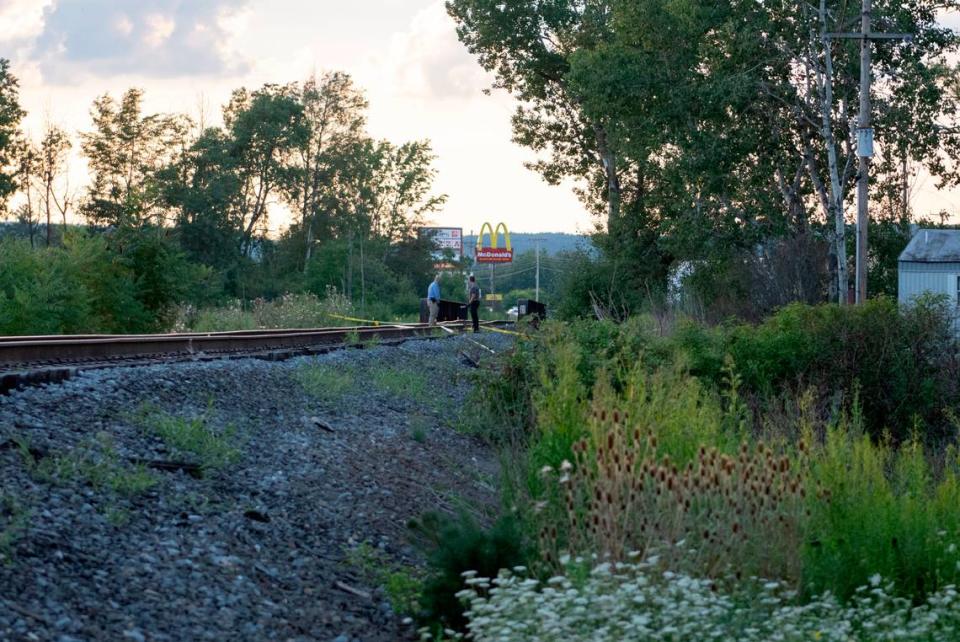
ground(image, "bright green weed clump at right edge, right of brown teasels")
xmin=804 ymin=416 xmax=960 ymax=598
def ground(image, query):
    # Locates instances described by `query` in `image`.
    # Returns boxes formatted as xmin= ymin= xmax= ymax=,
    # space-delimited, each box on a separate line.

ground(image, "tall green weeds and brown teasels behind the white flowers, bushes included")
xmin=464 ymin=302 xmax=960 ymax=600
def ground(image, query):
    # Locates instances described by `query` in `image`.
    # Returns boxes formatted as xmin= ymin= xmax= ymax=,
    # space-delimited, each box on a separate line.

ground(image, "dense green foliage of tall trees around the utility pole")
xmin=447 ymin=0 xmax=960 ymax=308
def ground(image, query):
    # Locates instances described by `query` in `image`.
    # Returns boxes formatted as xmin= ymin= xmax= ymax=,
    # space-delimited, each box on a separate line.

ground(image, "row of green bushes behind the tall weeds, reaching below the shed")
xmin=484 ymin=298 xmax=960 ymax=444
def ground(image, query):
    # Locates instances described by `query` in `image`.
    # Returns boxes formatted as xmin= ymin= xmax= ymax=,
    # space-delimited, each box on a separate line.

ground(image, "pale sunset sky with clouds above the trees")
xmin=0 ymin=0 xmax=960 ymax=233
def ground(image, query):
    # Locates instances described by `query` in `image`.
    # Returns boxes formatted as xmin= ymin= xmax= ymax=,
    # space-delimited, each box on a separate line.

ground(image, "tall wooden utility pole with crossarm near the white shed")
xmin=824 ymin=0 xmax=913 ymax=303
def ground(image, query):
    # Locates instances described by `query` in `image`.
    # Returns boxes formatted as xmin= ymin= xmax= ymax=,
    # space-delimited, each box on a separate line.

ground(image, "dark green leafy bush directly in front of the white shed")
xmin=728 ymin=298 xmax=960 ymax=440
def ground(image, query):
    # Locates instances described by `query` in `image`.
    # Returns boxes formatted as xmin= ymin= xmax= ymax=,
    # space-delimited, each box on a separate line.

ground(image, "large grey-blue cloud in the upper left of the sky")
xmin=32 ymin=0 xmax=249 ymax=83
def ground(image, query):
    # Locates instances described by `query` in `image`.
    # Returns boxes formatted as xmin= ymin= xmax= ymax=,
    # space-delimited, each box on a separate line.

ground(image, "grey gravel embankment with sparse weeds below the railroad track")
xmin=0 ymin=334 xmax=511 ymax=642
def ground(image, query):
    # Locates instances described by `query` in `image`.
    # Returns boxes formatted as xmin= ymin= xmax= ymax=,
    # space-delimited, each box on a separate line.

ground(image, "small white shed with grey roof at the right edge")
xmin=897 ymin=229 xmax=960 ymax=304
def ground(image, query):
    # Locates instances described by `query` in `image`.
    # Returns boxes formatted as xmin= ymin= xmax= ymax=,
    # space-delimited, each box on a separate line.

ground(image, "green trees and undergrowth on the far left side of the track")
xmin=0 ymin=59 xmax=454 ymax=334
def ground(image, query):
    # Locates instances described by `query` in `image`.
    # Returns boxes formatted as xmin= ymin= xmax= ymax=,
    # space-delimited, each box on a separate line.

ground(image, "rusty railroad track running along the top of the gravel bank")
xmin=0 ymin=321 xmax=504 ymax=394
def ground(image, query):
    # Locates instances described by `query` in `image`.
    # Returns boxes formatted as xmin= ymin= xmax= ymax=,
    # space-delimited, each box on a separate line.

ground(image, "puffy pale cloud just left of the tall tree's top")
xmin=380 ymin=0 xmax=490 ymax=99
